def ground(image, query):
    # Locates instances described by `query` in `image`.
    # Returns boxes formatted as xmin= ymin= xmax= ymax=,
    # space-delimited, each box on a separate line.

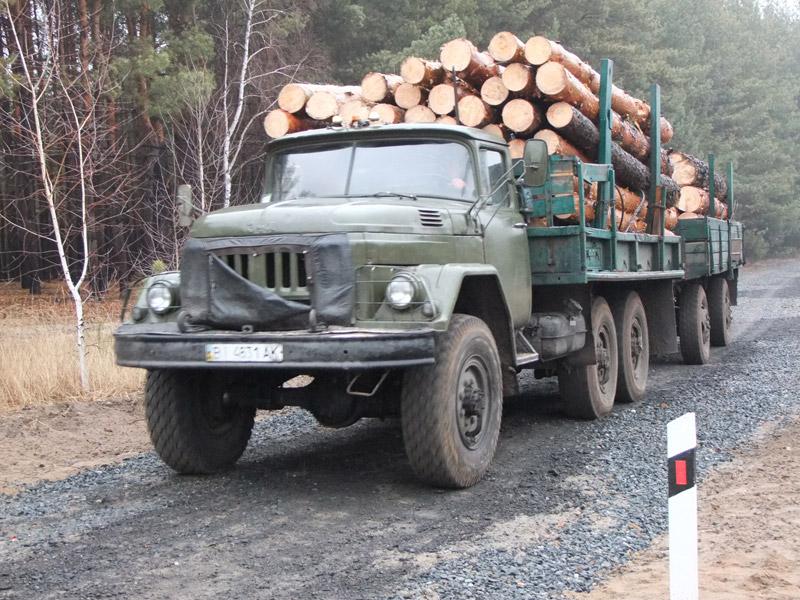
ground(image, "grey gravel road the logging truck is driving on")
xmin=0 ymin=261 xmax=800 ymax=599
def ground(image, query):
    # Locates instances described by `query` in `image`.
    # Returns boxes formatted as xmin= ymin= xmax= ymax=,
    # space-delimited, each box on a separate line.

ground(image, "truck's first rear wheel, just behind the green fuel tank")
xmin=558 ymin=296 xmax=619 ymax=419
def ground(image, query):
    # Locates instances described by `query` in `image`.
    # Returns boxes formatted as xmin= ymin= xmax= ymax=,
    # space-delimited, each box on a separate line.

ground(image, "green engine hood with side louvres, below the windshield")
xmin=192 ymin=198 xmax=474 ymax=237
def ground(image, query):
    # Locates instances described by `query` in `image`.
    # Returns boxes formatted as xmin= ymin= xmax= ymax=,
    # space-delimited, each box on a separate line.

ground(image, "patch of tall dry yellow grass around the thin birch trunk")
xmin=0 ymin=283 xmax=143 ymax=411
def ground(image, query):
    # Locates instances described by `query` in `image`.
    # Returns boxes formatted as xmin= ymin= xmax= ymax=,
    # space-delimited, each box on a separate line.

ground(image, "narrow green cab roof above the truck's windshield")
xmin=269 ymin=123 xmax=505 ymax=148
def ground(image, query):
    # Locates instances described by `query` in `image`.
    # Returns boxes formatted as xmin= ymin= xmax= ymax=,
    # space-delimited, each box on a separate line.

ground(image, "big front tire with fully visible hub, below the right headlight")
xmin=400 ymin=315 xmax=503 ymax=488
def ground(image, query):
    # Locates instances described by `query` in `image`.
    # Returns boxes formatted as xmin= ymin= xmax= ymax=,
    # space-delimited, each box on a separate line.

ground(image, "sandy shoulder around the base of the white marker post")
xmin=573 ymin=421 xmax=800 ymax=600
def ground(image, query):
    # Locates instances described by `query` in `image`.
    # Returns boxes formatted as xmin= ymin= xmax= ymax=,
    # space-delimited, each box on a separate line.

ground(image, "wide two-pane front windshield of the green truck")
xmin=265 ymin=141 xmax=477 ymax=202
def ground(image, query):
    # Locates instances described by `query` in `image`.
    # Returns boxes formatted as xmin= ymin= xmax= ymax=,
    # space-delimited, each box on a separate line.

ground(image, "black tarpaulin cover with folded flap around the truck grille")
xmin=181 ymin=233 xmax=355 ymax=331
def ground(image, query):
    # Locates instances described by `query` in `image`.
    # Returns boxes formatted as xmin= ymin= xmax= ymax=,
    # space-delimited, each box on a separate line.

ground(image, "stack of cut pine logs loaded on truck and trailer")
xmin=264 ymin=31 xmax=727 ymax=232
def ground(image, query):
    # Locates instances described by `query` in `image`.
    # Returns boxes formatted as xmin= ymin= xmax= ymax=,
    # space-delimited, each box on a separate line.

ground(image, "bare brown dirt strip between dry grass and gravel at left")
xmin=0 ymin=400 xmax=150 ymax=494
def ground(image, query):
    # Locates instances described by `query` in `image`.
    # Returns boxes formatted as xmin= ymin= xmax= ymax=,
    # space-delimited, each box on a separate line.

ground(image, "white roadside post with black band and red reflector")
xmin=667 ymin=413 xmax=699 ymax=600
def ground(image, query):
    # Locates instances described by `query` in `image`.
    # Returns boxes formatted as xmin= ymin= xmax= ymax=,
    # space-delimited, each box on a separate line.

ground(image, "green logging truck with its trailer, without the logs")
xmin=115 ymin=61 xmax=744 ymax=487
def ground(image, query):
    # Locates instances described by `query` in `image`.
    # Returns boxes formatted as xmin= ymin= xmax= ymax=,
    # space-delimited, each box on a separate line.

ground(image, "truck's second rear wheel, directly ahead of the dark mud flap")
xmin=611 ymin=292 xmax=650 ymax=402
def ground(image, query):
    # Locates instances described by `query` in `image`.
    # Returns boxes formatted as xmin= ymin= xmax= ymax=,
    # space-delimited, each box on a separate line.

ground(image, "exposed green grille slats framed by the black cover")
xmin=220 ymin=251 xmax=309 ymax=299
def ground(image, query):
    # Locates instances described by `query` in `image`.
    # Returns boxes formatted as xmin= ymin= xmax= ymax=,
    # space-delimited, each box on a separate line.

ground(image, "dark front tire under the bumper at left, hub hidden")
xmin=144 ymin=370 xmax=255 ymax=474
